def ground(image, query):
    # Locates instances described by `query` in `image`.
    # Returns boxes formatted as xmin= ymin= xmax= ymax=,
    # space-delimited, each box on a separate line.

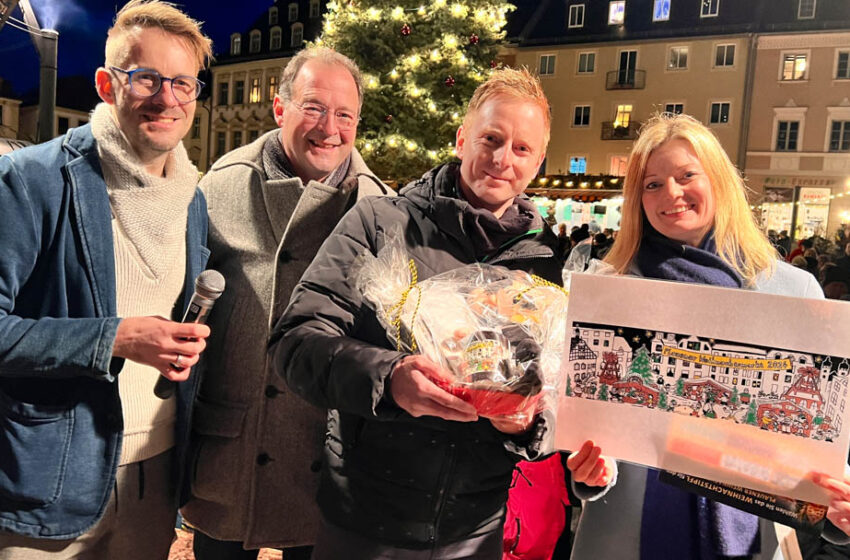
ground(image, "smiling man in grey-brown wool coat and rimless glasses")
xmin=182 ymin=47 xmax=392 ymax=560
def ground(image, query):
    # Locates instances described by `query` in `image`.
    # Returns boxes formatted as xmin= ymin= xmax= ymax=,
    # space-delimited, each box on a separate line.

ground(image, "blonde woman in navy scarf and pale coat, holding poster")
xmin=573 ymin=115 xmax=850 ymax=560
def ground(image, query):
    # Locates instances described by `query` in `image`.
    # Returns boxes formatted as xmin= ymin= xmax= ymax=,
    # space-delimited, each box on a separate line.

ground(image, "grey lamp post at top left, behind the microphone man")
xmin=16 ymin=0 xmax=59 ymax=142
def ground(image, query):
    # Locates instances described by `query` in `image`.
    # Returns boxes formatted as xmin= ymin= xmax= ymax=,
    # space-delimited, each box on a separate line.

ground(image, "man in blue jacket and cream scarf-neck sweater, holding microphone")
xmin=0 ymin=0 xmax=211 ymax=560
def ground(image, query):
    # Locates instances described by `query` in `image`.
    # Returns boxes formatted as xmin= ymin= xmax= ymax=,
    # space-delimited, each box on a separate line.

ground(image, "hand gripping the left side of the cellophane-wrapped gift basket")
xmin=390 ymin=355 xmax=478 ymax=422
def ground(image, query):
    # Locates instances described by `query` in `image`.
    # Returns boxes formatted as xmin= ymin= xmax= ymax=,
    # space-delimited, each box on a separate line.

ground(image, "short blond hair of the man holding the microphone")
xmin=106 ymin=0 xmax=212 ymax=69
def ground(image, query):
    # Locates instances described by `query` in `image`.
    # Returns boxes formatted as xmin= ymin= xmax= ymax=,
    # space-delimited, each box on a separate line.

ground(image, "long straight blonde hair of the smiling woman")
xmin=605 ymin=113 xmax=777 ymax=285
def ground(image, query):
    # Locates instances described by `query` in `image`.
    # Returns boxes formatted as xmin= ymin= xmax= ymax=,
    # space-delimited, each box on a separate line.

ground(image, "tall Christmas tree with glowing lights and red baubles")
xmin=317 ymin=0 xmax=514 ymax=179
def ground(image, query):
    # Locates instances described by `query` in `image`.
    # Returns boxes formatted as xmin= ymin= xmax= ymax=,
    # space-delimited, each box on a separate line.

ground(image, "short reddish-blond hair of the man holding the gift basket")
xmin=463 ymin=66 xmax=551 ymax=151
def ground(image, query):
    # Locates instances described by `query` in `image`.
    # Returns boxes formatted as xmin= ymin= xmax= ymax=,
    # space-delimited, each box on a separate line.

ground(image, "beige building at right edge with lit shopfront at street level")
xmin=745 ymin=31 xmax=850 ymax=239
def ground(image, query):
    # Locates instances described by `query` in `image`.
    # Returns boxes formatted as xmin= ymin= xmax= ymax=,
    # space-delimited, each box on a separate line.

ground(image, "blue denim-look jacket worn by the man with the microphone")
xmin=0 ymin=125 xmax=209 ymax=539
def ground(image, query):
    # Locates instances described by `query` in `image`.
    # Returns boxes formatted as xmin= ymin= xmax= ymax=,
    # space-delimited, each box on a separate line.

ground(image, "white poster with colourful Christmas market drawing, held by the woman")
xmin=556 ymin=274 xmax=850 ymax=504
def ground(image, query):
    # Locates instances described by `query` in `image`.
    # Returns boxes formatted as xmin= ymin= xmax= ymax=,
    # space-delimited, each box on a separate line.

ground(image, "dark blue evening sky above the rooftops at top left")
xmin=0 ymin=0 xmax=272 ymax=94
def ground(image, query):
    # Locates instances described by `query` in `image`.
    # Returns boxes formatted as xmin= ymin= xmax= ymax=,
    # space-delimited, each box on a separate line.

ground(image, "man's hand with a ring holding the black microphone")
xmin=112 ymin=317 xmax=210 ymax=381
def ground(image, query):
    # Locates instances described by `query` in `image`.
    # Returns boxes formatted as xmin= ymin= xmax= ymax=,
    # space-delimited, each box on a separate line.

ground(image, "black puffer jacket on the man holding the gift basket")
xmin=270 ymin=164 xmax=561 ymax=548
